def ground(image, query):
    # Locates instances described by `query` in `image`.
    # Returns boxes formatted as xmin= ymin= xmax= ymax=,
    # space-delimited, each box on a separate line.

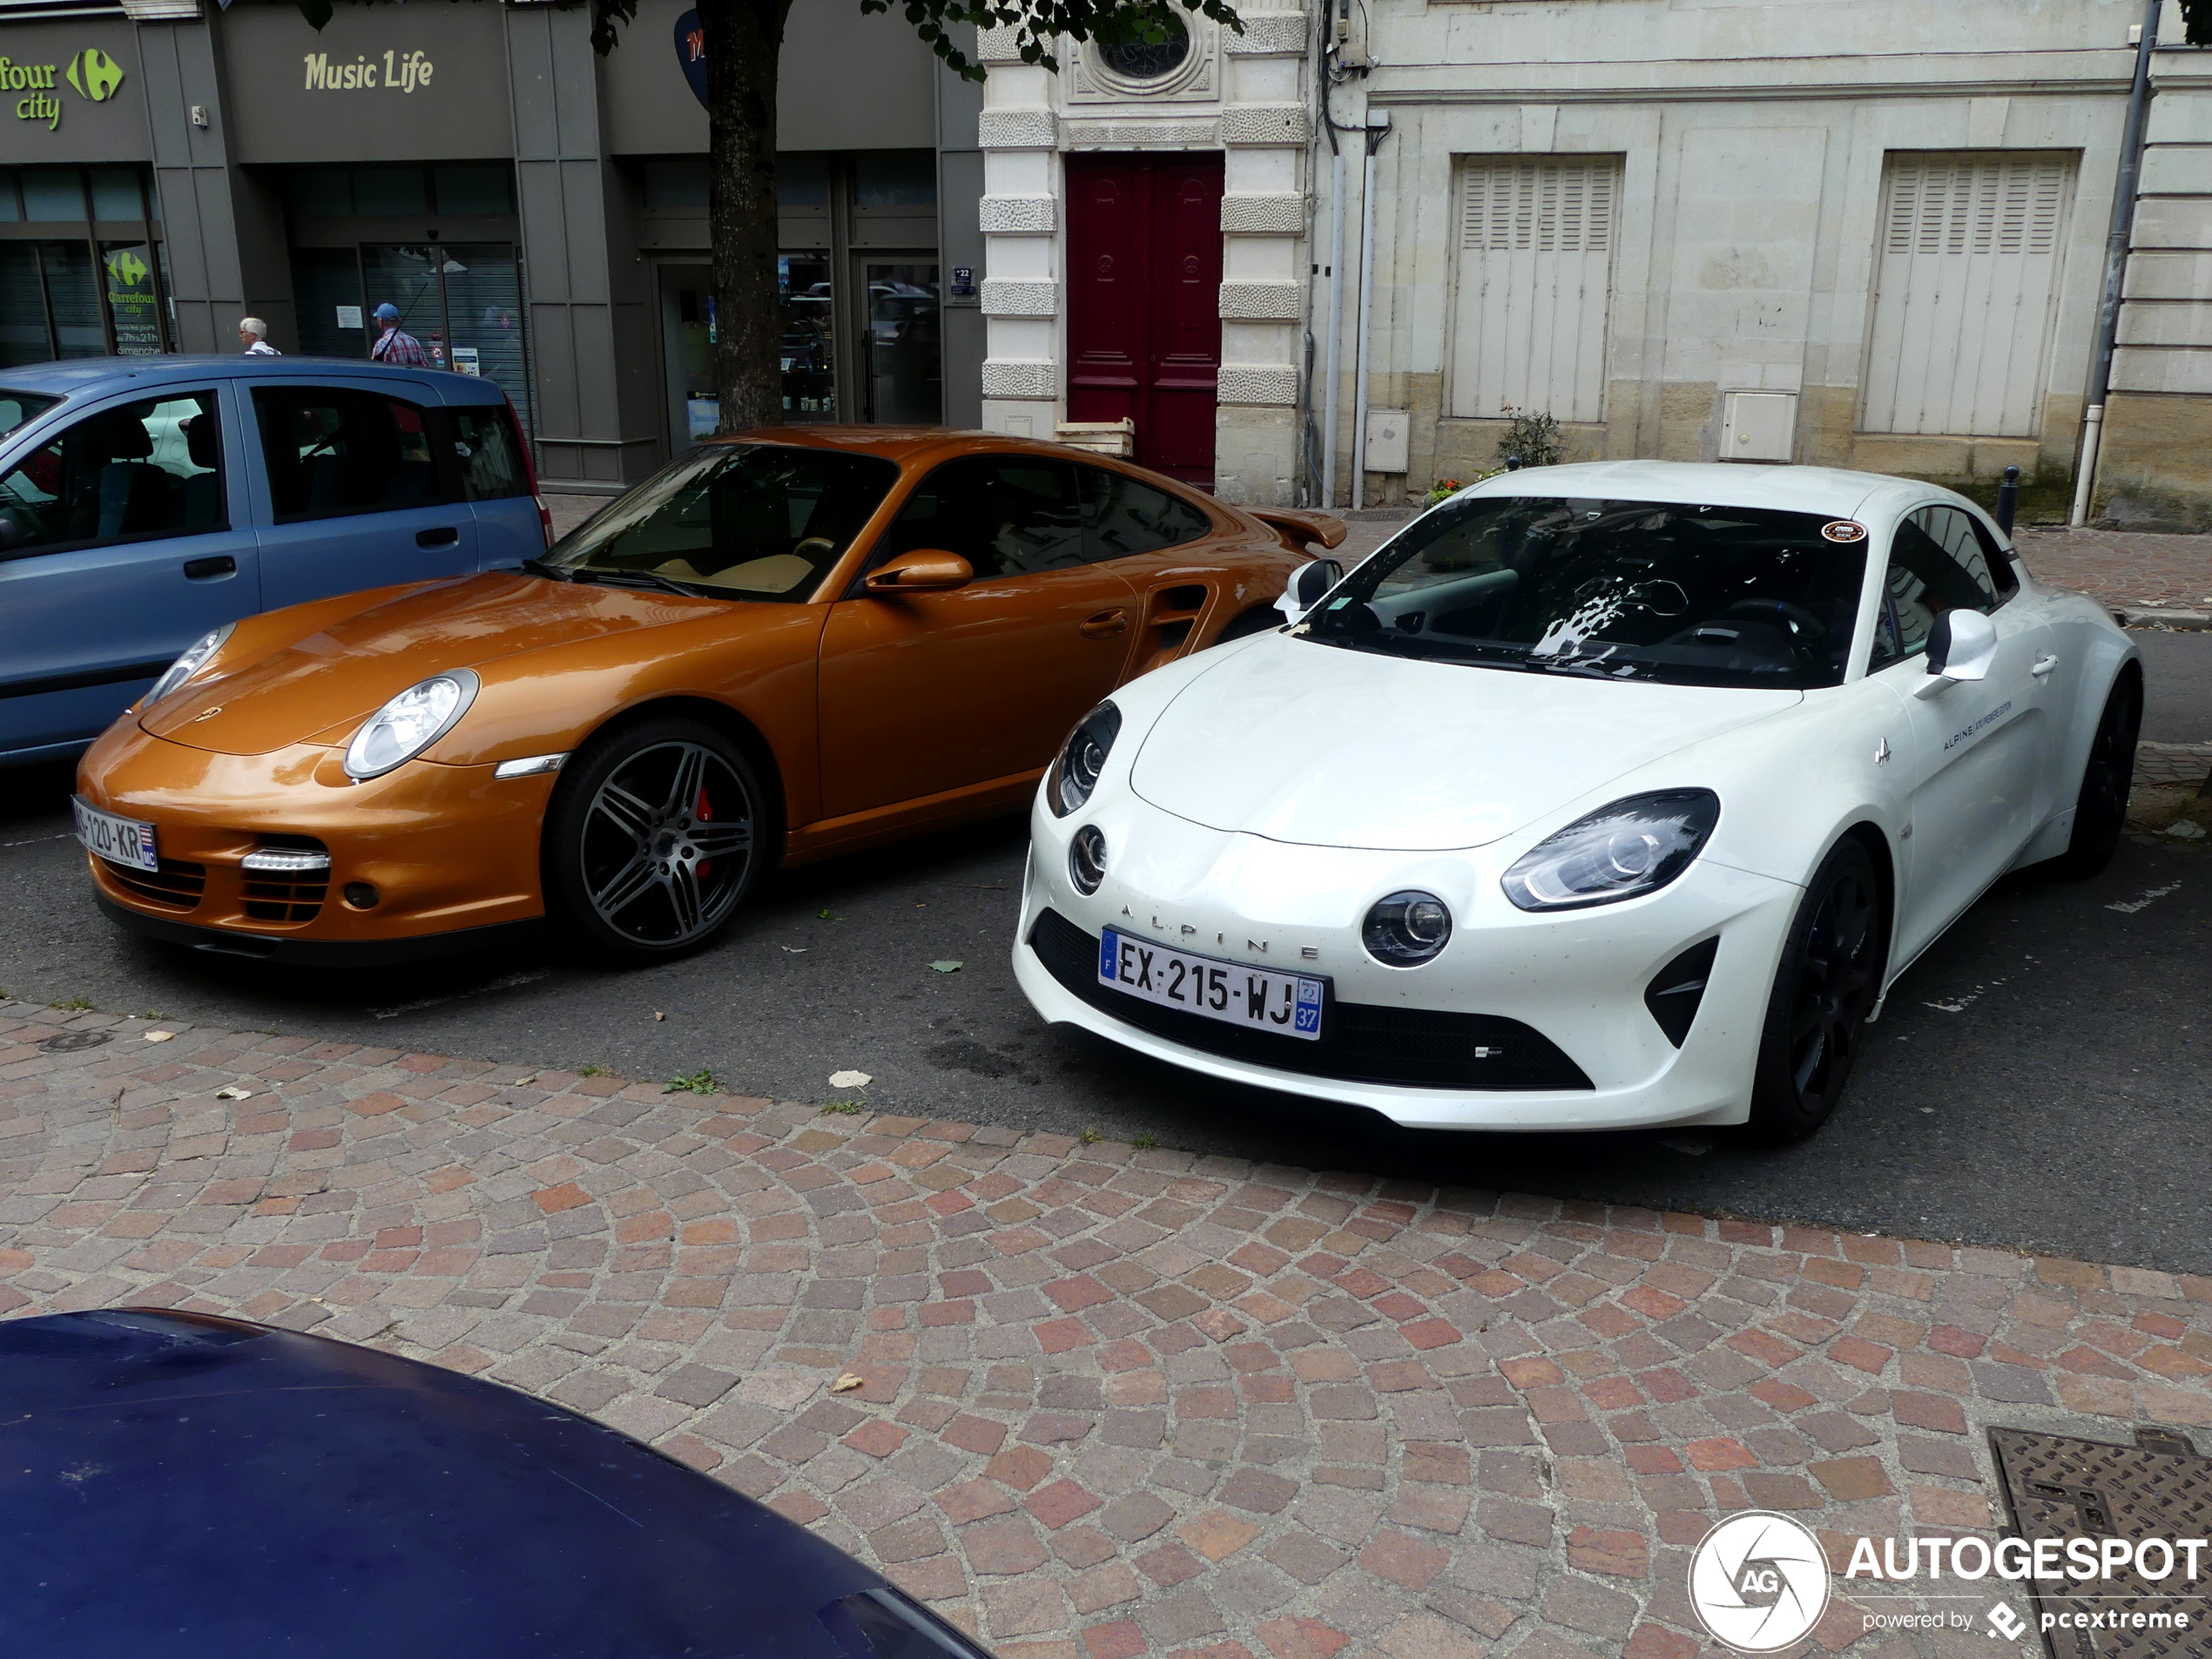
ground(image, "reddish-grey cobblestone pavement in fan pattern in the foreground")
xmin=0 ymin=1002 xmax=2212 ymax=1659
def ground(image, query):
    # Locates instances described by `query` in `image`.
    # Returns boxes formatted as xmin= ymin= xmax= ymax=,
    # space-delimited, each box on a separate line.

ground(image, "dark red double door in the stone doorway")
xmin=1066 ymin=155 xmax=1221 ymax=489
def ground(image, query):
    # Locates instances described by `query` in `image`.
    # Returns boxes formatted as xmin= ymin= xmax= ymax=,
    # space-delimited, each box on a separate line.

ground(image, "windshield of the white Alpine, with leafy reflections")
xmin=1307 ymin=496 xmax=1867 ymax=690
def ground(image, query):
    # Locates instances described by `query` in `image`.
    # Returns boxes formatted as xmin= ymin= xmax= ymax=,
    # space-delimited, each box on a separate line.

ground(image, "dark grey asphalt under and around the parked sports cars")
xmin=0 ymin=635 xmax=2212 ymax=1272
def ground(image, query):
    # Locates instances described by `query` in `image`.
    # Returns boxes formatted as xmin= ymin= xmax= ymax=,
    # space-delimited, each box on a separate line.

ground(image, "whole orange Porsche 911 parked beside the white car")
xmin=75 ymin=427 xmax=1345 ymax=964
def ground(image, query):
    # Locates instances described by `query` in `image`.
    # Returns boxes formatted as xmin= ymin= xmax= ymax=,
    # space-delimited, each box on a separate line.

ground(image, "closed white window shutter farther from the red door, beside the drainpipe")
xmin=1860 ymin=151 xmax=2075 ymax=438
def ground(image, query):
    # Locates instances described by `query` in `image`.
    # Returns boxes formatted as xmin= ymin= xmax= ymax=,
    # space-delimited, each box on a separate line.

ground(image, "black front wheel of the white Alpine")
xmin=1743 ymin=839 xmax=1887 ymax=1146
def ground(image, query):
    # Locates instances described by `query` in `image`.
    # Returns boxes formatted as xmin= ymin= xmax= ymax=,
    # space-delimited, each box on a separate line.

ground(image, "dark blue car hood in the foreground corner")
xmin=0 ymin=1312 xmax=924 ymax=1659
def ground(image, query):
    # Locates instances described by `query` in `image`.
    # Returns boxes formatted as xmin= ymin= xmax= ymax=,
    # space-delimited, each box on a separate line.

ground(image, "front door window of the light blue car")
xmin=0 ymin=392 xmax=228 ymax=557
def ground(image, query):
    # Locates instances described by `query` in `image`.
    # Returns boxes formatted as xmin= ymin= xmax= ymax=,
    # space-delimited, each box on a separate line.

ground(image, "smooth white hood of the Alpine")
xmin=1130 ymin=635 xmax=1801 ymax=852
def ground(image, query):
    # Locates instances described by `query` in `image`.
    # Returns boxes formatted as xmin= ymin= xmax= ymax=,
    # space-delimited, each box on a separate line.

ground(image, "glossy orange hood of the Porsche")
xmin=139 ymin=573 xmax=730 ymax=754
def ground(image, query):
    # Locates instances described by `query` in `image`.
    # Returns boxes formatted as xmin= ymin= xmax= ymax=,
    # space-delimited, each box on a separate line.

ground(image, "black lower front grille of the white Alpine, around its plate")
xmin=1028 ymin=909 xmax=1595 ymax=1090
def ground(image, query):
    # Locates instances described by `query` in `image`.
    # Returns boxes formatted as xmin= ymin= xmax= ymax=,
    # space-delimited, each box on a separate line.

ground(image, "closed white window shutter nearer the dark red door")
xmin=1451 ymin=155 xmax=1622 ymax=421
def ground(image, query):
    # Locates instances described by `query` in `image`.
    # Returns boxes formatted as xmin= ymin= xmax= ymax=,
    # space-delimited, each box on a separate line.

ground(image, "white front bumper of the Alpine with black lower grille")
xmin=1013 ymin=790 xmax=1801 ymax=1130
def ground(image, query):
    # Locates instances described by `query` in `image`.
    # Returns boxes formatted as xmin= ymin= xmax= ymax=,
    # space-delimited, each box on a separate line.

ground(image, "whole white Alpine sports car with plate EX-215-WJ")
xmin=1013 ymin=462 xmax=2143 ymax=1143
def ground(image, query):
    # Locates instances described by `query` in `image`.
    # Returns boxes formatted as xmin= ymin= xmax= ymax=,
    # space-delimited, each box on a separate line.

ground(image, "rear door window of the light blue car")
xmin=254 ymin=385 xmax=451 ymax=524
